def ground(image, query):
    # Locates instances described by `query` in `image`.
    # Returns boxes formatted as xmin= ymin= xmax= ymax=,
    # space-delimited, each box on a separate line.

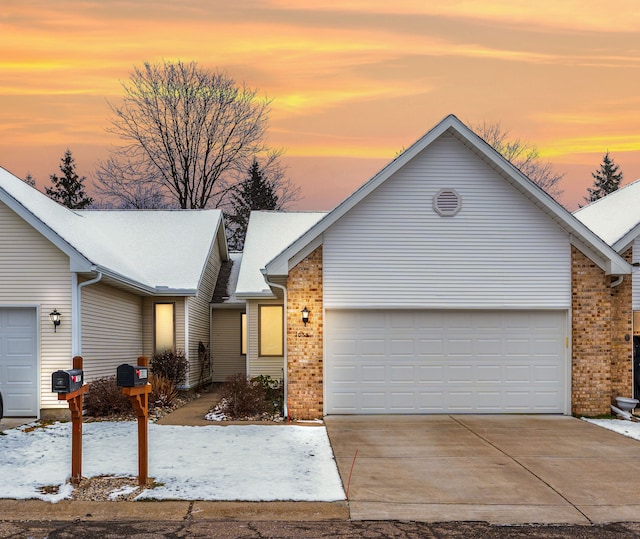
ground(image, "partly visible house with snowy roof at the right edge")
xmin=574 ymin=180 xmax=640 ymax=398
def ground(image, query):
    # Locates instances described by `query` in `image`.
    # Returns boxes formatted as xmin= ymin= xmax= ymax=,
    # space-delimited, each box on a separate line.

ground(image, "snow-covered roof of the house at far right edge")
xmin=573 ymin=180 xmax=640 ymax=253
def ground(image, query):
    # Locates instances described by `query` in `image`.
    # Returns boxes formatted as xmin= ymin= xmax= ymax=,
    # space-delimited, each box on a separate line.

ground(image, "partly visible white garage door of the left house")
xmin=0 ymin=307 xmax=38 ymax=417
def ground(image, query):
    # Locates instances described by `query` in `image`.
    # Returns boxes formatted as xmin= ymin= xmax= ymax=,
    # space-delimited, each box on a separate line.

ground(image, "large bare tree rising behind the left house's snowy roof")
xmin=98 ymin=61 xmax=271 ymax=208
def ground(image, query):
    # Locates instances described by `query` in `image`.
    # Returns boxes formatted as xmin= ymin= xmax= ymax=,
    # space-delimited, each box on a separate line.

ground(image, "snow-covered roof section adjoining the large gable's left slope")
xmin=236 ymin=211 xmax=326 ymax=296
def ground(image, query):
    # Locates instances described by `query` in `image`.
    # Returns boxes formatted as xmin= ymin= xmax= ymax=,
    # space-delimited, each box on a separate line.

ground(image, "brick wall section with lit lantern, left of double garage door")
xmin=287 ymin=246 xmax=324 ymax=419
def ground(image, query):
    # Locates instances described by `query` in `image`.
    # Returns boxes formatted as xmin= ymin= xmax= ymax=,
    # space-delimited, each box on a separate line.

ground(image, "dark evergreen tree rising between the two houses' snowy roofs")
xmin=227 ymin=159 xmax=278 ymax=251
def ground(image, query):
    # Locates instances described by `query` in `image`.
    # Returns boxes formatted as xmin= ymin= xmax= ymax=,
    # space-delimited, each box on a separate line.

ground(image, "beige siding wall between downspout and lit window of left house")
xmin=81 ymin=283 xmax=142 ymax=382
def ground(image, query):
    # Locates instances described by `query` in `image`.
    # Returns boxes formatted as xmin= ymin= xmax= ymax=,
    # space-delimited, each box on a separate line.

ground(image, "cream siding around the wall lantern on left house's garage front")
xmin=0 ymin=203 xmax=73 ymax=416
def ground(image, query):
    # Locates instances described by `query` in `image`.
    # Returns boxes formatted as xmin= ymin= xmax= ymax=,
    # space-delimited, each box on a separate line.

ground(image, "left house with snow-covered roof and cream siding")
xmin=0 ymin=169 xmax=228 ymax=417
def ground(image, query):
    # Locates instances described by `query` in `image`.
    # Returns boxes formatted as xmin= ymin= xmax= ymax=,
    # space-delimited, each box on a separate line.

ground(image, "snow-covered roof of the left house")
xmin=0 ymin=169 xmax=227 ymax=295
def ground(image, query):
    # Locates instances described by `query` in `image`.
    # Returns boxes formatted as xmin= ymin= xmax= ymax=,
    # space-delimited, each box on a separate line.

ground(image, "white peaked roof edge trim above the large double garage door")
xmin=266 ymin=115 xmax=631 ymax=278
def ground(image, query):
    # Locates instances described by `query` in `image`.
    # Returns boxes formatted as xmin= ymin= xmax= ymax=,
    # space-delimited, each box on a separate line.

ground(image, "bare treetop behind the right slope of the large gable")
xmin=471 ymin=122 xmax=564 ymax=200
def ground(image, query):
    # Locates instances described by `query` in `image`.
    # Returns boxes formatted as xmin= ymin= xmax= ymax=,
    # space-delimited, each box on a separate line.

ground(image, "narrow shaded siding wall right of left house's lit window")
xmin=187 ymin=243 xmax=222 ymax=387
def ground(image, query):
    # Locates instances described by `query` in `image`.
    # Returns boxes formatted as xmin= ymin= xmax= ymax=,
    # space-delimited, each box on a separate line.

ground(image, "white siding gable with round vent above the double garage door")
xmin=323 ymin=136 xmax=571 ymax=309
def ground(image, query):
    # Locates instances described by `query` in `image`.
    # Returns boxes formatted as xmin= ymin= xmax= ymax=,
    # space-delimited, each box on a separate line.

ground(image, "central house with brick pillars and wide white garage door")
xmin=228 ymin=116 xmax=632 ymax=419
